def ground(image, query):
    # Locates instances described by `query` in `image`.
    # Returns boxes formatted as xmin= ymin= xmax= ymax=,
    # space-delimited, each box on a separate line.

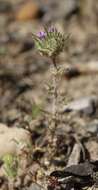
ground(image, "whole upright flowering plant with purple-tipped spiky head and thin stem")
xmin=33 ymin=26 xmax=69 ymax=149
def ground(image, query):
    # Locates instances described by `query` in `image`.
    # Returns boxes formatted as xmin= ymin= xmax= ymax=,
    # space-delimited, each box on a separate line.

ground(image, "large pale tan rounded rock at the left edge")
xmin=0 ymin=123 xmax=31 ymax=157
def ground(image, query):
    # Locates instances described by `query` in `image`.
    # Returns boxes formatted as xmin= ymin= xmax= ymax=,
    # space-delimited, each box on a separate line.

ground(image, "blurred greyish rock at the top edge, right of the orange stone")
xmin=43 ymin=0 xmax=78 ymax=21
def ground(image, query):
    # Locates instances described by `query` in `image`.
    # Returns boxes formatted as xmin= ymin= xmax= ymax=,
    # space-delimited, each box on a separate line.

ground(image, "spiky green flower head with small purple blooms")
xmin=33 ymin=27 xmax=68 ymax=57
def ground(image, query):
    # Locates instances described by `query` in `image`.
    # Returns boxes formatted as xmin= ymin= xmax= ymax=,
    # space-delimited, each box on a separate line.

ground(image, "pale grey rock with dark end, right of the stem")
xmin=62 ymin=96 xmax=98 ymax=116
